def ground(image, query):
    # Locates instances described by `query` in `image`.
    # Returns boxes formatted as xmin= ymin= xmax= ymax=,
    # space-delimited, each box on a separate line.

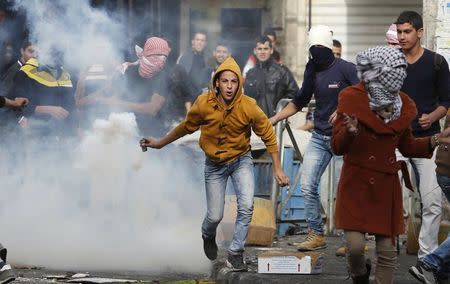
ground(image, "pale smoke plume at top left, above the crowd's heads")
xmin=13 ymin=0 xmax=127 ymax=70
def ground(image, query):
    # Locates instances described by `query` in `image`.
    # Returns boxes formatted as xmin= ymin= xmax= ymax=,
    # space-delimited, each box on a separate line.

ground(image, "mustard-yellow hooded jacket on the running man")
xmin=174 ymin=57 xmax=278 ymax=164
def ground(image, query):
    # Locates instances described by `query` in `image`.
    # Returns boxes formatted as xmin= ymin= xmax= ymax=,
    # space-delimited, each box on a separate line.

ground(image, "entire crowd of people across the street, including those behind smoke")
xmin=0 ymin=4 xmax=450 ymax=283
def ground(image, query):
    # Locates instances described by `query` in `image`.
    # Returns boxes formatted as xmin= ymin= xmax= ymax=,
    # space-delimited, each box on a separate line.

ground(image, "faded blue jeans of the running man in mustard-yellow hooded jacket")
xmin=202 ymin=152 xmax=255 ymax=254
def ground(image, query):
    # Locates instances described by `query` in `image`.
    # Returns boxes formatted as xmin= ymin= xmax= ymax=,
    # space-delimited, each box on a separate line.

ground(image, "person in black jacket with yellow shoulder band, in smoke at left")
xmin=12 ymin=46 xmax=78 ymax=137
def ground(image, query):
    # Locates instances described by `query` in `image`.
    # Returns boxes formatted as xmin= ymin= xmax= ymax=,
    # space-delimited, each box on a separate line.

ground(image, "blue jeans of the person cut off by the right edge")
xmin=420 ymin=174 xmax=450 ymax=278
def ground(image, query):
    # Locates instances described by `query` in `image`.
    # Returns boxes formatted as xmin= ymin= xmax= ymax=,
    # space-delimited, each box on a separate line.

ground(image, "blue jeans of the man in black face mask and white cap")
xmin=301 ymin=131 xmax=334 ymax=234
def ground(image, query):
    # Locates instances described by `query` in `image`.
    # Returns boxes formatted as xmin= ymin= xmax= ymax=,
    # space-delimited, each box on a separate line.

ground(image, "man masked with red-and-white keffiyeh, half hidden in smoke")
xmin=98 ymin=37 xmax=196 ymax=135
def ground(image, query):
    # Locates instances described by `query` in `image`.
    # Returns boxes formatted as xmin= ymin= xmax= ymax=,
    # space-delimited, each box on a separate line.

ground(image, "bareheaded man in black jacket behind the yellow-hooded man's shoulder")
xmin=244 ymin=36 xmax=298 ymax=117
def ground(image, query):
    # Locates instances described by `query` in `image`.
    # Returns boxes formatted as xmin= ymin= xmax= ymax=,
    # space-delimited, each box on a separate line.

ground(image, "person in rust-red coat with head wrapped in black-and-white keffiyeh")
xmin=331 ymin=47 xmax=441 ymax=283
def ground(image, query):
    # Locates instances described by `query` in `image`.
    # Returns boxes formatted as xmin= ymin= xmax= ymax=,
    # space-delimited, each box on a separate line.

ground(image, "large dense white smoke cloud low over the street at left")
xmin=0 ymin=113 xmax=209 ymax=273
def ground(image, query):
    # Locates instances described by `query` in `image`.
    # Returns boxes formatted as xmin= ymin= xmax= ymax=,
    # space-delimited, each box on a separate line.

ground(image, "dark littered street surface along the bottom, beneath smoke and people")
xmin=8 ymin=235 xmax=418 ymax=284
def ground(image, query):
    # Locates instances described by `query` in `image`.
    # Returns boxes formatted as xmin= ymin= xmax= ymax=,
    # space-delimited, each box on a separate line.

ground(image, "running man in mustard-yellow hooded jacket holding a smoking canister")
xmin=140 ymin=57 xmax=289 ymax=271
